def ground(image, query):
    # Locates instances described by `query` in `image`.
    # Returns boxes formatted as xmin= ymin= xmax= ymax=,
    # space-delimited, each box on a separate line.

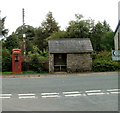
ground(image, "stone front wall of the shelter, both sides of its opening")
xmin=49 ymin=53 xmax=92 ymax=73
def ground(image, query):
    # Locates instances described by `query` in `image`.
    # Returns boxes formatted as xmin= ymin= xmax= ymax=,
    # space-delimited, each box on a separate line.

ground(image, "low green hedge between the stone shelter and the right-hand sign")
xmin=92 ymin=51 xmax=120 ymax=72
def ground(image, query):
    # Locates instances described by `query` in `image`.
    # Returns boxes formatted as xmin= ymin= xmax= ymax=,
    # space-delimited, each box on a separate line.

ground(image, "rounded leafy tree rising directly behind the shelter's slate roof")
xmin=67 ymin=14 xmax=94 ymax=38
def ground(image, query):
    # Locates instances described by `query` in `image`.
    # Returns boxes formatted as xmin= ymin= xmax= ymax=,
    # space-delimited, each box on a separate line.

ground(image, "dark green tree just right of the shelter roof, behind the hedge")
xmin=91 ymin=21 xmax=114 ymax=51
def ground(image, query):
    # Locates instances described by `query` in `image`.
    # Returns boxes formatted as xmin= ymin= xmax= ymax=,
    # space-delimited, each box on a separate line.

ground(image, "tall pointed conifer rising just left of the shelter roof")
xmin=34 ymin=12 xmax=59 ymax=51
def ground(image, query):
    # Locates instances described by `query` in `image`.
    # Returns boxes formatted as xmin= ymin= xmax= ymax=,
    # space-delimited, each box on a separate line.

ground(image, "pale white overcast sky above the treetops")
xmin=0 ymin=0 xmax=120 ymax=34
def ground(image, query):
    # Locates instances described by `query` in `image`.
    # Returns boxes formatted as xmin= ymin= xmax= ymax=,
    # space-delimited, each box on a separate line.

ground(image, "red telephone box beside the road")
xmin=12 ymin=49 xmax=22 ymax=73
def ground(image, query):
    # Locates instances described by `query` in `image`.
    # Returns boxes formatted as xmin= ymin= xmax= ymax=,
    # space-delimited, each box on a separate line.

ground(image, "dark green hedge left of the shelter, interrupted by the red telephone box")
xmin=2 ymin=48 xmax=48 ymax=73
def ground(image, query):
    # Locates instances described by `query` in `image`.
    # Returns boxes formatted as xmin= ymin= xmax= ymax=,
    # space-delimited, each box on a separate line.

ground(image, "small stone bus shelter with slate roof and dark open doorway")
xmin=48 ymin=38 xmax=93 ymax=73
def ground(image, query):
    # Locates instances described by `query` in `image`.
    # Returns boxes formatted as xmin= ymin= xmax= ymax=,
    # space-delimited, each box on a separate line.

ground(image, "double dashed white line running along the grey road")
xmin=0 ymin=89 xmax=120 ymax=99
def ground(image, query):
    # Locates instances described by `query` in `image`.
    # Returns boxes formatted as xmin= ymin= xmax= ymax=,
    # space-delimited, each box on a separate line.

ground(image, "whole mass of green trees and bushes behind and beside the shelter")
xmin=2 ymin=12 xmax=116 ymax=72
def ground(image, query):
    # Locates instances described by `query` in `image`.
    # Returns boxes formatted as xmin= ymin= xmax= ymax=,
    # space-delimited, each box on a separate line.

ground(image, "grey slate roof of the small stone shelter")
xmin=48 ymin=38 xmax=93 ymax=53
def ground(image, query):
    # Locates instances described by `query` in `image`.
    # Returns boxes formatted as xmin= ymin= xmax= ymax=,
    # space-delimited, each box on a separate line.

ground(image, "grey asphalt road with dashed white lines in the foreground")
xmin=0 ymin=73 xmax=119 ymax=111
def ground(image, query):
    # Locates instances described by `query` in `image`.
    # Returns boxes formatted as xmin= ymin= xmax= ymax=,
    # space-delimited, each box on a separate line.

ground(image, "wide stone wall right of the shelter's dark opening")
xmin=67 ymin=53 xmax=92 ymax=72
